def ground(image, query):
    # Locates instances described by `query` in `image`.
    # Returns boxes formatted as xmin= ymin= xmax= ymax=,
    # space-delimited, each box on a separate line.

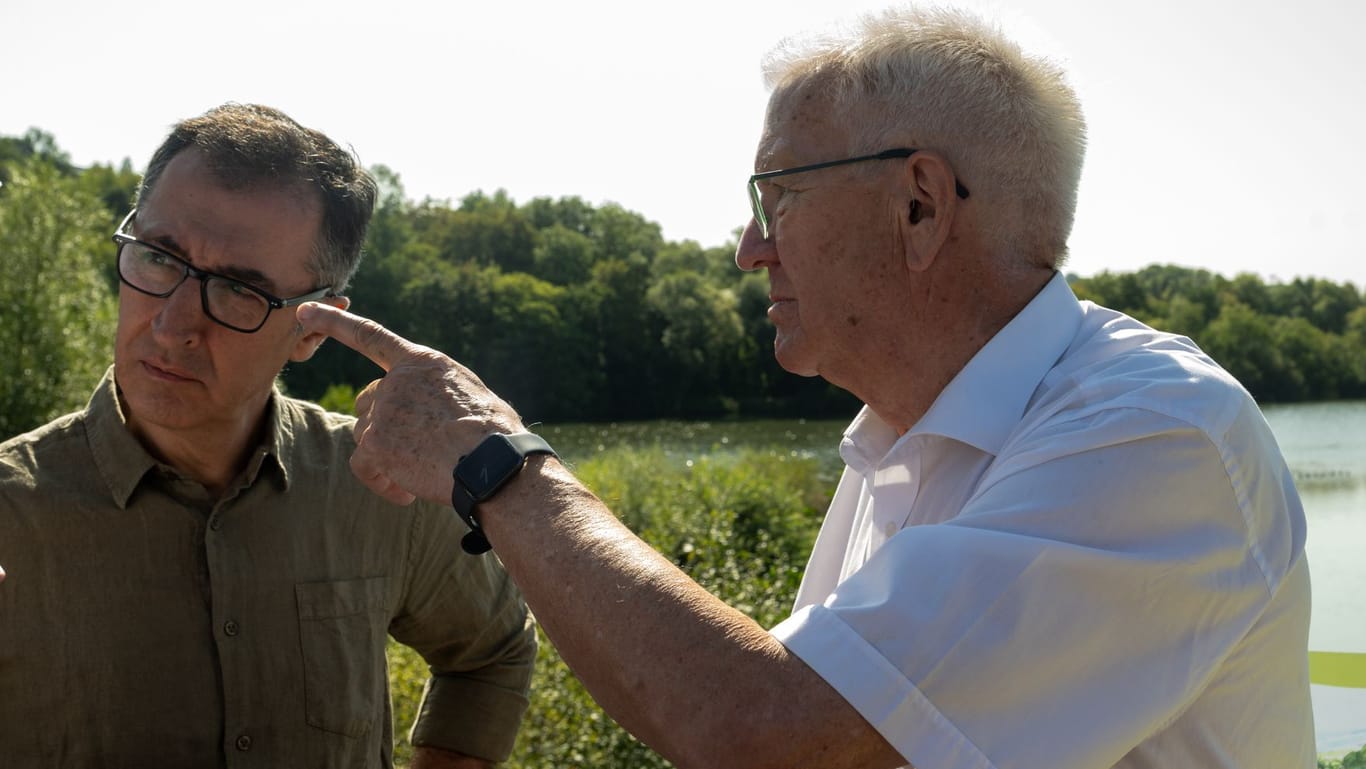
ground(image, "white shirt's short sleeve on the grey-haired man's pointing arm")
xmin=773 ymin=413 xmax=1290 ymax=769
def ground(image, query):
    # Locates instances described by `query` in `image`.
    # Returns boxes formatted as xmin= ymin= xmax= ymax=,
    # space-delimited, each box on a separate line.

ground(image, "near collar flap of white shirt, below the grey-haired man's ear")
xmin=907 ymin=273 xmax=1082 ymax=455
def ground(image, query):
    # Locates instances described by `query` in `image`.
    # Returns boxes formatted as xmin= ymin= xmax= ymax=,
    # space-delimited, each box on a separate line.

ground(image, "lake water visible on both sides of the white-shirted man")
xmin=535 ymin=402 xmax=1366 ymax=754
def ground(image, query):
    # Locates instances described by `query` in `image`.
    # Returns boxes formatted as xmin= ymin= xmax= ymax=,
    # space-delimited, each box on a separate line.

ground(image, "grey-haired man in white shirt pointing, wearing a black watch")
xmin=299 ymin=8 xmax=1314 ymax=769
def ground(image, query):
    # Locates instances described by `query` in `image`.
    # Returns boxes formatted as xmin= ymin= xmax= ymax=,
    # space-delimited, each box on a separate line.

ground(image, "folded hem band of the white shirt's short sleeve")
xmin=770 ymin=606 xmax=993 ymax=769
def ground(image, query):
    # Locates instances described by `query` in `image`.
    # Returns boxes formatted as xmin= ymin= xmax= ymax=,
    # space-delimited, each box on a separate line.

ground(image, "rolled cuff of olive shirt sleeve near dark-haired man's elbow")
xmin=411 ymin=676 xmax=527 ymax=762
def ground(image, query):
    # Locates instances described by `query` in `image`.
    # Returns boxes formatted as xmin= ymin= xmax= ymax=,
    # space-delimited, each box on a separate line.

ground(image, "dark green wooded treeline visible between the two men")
xmin=284 ymin=168 xmax=854 ymax=421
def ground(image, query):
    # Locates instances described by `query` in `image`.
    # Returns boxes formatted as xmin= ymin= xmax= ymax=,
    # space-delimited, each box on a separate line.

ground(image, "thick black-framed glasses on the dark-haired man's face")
xmin=113 ymin=209 xmax=332 ymax=333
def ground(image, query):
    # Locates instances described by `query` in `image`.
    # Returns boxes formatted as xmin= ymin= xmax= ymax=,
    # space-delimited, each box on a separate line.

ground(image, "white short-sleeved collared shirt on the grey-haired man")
xmin=772 ymin=276 xmax=1315 ymax=769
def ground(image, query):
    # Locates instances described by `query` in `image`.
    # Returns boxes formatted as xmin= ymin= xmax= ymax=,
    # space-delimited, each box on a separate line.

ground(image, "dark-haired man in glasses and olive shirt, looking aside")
xmin=0 ymin=104 xmax=535 ymax=768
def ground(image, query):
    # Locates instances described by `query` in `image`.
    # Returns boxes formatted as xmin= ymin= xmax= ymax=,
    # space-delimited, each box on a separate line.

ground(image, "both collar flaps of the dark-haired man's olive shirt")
xmin=83 ymin=366 xmax=295 ymax=509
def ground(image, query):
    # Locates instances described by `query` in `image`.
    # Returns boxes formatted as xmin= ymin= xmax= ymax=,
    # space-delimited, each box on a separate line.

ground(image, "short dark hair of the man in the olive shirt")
xmin=138 ymin=102 xmax=378 ymax=292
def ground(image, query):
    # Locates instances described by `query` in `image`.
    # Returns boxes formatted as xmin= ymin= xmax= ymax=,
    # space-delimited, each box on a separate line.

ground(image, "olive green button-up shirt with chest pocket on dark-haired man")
xmin=0 ymin=372 xmax=535 ymax=769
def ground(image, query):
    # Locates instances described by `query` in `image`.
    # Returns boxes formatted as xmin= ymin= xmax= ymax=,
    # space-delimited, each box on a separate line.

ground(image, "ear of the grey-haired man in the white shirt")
xmin=900 ymin=150 xmax=962 ymax=272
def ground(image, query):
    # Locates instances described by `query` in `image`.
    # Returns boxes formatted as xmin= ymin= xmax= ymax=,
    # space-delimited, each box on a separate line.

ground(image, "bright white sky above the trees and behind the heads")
xmin=0 ymin=0 xmax=1366 ymax=288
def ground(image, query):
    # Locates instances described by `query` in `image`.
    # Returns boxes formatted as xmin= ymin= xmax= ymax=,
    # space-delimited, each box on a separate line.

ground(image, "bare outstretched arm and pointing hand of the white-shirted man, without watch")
xmin=298 ymin=305 xmax=904 ymax=768
